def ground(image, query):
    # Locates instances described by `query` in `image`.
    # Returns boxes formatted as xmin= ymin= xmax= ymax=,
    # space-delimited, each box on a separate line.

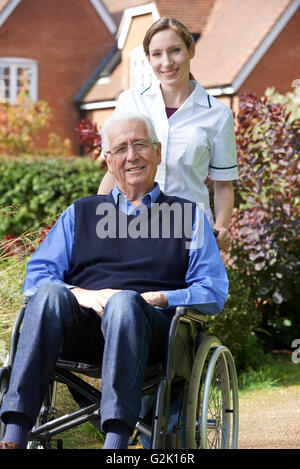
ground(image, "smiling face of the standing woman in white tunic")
xmin=148 ymin=29 xmax=195 ymax=86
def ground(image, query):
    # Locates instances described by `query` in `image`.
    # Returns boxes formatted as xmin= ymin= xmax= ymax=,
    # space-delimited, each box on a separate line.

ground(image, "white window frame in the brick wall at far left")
xmin=0 ymin=57 xmax=38 ymax=104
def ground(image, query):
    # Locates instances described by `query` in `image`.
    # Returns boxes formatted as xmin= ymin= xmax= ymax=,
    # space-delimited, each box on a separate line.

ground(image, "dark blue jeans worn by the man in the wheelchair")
xmin=1 ymin=283 xmax=171 ymax=431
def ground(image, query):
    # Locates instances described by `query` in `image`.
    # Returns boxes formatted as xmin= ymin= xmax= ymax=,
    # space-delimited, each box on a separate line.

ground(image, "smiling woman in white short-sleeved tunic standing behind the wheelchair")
xmin=98 ymin=17 xmax=238 ymax=250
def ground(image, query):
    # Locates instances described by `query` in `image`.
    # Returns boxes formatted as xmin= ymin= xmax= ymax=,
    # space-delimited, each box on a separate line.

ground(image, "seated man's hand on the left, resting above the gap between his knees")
xmin=71 ymin=288 xmax=121 ymax=317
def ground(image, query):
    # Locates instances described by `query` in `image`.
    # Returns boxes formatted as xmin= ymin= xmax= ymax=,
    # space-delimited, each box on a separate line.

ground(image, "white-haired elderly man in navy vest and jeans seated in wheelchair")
xmin=0 ymin=111 xmax=228 ymax=449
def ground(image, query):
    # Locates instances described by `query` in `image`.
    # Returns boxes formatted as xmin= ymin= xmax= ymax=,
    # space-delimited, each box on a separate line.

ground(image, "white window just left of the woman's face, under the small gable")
xmin=129 ymin=46 xmax=156 ymax=89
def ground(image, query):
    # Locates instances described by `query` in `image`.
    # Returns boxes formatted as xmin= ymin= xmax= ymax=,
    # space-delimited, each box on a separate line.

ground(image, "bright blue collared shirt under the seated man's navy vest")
xmin=22 ymin=184 xmax=228 ymax=315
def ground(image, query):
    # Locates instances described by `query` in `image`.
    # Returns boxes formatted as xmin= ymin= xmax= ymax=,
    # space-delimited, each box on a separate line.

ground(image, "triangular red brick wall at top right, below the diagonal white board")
xmin=238 ymin=10 xmax=300 ymax=96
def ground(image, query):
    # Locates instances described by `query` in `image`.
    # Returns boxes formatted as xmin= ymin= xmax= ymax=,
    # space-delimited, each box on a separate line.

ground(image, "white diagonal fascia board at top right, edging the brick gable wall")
xmin=232 ymin=0 xmax=300 ymax=92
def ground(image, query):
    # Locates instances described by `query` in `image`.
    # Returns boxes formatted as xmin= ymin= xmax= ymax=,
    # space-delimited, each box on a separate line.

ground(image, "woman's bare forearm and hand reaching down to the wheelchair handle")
xmin=214 ymin=181 xmax=234 ymax=251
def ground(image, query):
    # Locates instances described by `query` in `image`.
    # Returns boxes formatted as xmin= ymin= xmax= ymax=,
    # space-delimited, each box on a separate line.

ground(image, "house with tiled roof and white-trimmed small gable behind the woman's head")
xmin=76 ymin=0 xmax=300 ymax=130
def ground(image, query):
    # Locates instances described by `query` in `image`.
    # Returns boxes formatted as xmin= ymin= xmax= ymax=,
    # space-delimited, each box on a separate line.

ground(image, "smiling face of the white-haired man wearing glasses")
xmin=105 ymin=120 xmax=161 ymax=194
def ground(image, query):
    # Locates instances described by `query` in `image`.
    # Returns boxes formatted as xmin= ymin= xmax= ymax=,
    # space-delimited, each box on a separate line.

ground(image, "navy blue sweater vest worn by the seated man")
xmin=65 ymin=193 xmax=195 ymax=293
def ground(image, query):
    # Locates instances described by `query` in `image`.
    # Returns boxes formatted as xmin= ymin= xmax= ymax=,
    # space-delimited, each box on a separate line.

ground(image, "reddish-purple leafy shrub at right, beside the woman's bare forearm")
xmin=230 ymin=88 xmax=300 ymax=350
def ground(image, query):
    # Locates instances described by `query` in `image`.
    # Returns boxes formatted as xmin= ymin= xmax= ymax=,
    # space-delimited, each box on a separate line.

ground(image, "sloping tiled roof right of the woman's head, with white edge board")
xmin=191 ymin=0 xmax=299 ymax=94
